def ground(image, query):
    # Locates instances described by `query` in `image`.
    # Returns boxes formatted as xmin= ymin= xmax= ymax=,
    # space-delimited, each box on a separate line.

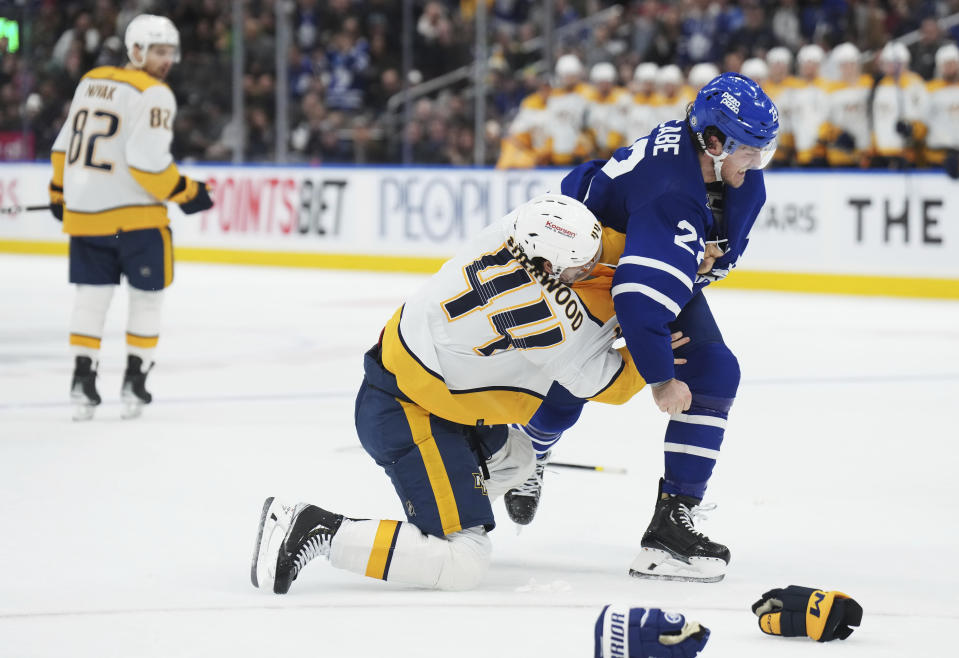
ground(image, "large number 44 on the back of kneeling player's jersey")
xmin=443 ymin=247 xmax=563 ymax=356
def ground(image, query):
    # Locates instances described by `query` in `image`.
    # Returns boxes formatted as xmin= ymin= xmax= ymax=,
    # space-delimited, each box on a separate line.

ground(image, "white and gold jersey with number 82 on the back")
xmin=51 ymin=66 xmax=180 ymax=235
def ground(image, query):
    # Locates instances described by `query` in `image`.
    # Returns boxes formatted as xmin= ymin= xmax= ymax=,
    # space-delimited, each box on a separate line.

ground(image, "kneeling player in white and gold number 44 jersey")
xmin=251 ymin=194 xmax=679 ymax=594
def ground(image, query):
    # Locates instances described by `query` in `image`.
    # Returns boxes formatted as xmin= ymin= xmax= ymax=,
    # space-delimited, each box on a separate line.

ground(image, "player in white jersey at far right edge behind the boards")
xmin=925 ymin=43 xmax=959 ymax=178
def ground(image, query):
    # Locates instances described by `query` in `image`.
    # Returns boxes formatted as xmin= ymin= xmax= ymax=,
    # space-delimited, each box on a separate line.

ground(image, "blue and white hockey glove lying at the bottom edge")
xmin=594 ymin=606 xmax=709 ymax=658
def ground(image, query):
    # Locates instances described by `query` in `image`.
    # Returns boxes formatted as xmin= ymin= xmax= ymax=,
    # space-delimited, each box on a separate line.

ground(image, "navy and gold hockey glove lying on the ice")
xmin=752 ymin=585 xmax=862 ymax=642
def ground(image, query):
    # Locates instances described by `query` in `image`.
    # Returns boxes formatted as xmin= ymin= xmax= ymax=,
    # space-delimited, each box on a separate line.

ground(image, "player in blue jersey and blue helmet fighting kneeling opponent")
xmin=506 ymin=73 xmax=779 ymax=582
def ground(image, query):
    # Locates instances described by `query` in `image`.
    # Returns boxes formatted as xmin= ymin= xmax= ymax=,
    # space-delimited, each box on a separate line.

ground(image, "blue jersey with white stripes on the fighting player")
xmin=561 ymin=121 xmax=766 ymax=382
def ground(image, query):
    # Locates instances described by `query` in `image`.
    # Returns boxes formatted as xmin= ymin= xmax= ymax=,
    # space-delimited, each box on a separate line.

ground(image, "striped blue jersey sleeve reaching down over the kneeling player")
xmin=612 ymin=196 xmax=705 ymax=383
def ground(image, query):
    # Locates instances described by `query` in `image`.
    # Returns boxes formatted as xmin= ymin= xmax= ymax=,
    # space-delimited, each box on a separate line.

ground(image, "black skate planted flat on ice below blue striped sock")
xmin=629 ymin=480 xmax=729 ymax=583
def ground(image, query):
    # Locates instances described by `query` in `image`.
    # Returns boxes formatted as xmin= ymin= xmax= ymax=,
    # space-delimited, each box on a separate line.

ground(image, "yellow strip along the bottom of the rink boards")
xmin=0 ymin=240 xmax=959 ymax=299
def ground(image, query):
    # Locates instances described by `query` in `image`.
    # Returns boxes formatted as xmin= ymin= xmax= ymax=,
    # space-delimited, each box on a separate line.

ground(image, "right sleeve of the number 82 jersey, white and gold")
xmin=126 ymin=85 xmax=180 ymax=201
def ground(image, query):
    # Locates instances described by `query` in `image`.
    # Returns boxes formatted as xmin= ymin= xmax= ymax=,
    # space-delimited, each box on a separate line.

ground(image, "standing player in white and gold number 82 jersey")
xmin=50 ymin=14 xmax=213 ymax=420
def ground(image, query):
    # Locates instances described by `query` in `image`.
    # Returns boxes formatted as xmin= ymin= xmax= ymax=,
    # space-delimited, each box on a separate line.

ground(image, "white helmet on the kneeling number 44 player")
xmin=508 ymin=193 xmax=603 ymax=283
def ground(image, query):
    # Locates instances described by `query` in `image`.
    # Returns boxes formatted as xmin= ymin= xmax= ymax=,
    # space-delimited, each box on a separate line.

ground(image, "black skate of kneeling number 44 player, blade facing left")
xmin=250 ymin=497 xmax=344 ymax=594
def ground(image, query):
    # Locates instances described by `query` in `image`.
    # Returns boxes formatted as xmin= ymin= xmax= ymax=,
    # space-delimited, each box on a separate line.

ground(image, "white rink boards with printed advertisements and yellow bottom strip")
xmin=0 ymin=164 xmax=959 ymax=299
